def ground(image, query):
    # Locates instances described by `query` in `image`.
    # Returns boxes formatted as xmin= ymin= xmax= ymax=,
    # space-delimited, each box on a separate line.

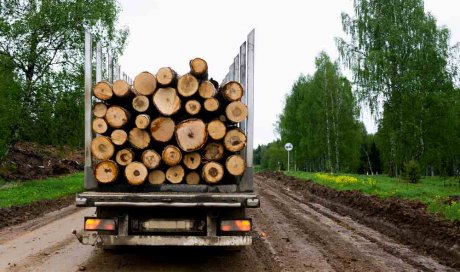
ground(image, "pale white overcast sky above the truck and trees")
xmin=116 ymin=0 xmax=460 ymax=147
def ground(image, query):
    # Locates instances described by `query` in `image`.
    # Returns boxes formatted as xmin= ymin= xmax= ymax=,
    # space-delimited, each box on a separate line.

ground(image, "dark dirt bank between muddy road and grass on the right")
xmin=261 ymin=172 xmax=460 ymax=269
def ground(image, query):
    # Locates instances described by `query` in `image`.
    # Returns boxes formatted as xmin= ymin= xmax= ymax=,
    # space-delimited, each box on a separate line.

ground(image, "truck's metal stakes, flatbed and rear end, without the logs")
xmin=76 ymin=30 xmax=259 ymax=248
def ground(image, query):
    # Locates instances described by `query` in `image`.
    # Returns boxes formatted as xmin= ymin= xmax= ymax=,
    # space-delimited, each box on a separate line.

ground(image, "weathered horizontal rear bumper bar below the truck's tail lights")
xmin=78 ymin=232 xmax=252 ymax=247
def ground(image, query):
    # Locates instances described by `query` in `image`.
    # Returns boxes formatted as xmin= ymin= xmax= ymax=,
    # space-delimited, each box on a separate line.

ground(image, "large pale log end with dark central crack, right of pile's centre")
xmin=176 ymin=119 xmax=208 ymax=152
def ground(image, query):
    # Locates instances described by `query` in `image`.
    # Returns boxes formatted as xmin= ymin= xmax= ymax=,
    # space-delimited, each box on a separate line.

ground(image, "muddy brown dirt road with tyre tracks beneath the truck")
xmin=0 ymin=177 xmax=455 ymax=271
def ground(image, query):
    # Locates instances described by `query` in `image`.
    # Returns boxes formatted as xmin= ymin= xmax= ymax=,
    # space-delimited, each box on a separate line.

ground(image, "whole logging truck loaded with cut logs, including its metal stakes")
xmin=74 ymin=30 xmax=260 ymax=248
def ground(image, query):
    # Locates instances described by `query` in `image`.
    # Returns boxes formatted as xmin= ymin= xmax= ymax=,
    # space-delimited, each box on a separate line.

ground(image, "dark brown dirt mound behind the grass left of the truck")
xmin=0 ymin=142 xmax=84 ymax=180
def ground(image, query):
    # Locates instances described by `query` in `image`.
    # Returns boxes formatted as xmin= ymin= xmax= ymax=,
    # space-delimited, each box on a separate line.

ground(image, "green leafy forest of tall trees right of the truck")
xmin=254 ymin=0 xmax=460 ymax=176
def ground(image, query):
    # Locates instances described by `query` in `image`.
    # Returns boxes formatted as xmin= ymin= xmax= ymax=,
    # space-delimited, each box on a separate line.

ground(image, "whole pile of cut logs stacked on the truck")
xmin=91 ymin=58 xmax=248 ymax=186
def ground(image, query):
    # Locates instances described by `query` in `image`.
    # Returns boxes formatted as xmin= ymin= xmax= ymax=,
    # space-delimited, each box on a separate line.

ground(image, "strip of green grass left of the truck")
xmin=0 ymin=173 xmax=83 ymax=208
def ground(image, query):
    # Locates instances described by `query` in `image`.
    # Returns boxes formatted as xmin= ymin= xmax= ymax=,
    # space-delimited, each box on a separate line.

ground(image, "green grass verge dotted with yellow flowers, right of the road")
xmin=286 ymin=172 xmax=460 ymax=221
